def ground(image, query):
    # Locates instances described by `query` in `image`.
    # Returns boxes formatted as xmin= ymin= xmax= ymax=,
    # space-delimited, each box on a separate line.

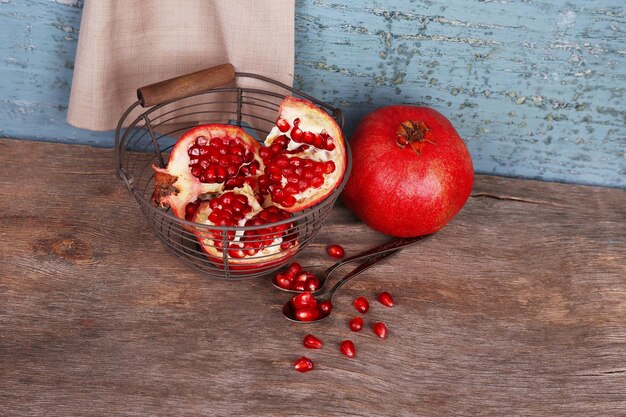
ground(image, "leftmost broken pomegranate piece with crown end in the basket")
xmin=153 ymin=124 xmax=263 ymax=220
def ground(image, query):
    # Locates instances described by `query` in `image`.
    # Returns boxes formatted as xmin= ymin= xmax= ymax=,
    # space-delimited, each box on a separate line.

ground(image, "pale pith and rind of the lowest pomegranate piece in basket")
xmin=193 ymin=184 xmax=297 ymax=264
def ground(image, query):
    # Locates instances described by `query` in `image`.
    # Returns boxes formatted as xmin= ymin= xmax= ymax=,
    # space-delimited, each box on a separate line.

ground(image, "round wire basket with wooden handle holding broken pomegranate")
xmin=115 ymin=64 xmax=351 ymax=279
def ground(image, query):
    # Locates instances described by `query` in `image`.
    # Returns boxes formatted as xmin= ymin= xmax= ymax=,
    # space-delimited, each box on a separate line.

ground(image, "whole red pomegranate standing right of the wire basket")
xmin=343 ymin=105 xmax=474 ymax=237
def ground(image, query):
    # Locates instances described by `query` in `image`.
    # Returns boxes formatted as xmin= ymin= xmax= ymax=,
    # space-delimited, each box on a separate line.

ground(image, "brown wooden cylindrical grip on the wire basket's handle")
xmin=137 ymin=64 xmax=235 ymax=107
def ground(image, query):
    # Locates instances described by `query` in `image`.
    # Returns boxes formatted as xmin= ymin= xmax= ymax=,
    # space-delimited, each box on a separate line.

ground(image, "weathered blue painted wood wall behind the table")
xmin=0 ymin=0 xmax=626 ymax=187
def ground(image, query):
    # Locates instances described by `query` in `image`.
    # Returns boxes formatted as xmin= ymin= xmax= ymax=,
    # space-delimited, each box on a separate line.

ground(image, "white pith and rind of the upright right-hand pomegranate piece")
xmin=265 ymin=97 xmax=347 ymax=211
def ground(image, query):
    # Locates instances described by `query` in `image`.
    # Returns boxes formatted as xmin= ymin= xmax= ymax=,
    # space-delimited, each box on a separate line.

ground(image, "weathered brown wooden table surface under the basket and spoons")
xmin=0 ymin=140 xmax=626 ymax=416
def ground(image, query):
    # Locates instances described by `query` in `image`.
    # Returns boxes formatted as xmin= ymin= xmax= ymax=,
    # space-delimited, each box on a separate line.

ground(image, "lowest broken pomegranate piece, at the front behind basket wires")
xmin=192 ymin=184 xmax=298 ymax=270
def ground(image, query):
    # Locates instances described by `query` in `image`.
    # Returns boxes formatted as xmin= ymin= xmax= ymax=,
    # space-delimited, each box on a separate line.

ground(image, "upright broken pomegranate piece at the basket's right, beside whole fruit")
xmin=258 ymin=97 xmax=347 ymax=212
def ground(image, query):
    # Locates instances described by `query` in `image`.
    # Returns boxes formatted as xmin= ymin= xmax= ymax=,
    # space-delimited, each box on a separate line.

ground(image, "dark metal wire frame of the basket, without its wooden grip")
xmin=115 ymin=72 xmax=352 ymax=279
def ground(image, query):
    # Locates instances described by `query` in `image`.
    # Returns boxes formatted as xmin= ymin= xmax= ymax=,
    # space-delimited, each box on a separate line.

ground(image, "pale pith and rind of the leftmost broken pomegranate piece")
xmin=152 ymin=125 xmax=263 ymax=219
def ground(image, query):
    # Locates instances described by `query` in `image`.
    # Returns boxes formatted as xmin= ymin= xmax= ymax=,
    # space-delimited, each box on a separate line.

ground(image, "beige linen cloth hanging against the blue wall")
xmin=67 ymin=0 xmax=295 ymax=130
